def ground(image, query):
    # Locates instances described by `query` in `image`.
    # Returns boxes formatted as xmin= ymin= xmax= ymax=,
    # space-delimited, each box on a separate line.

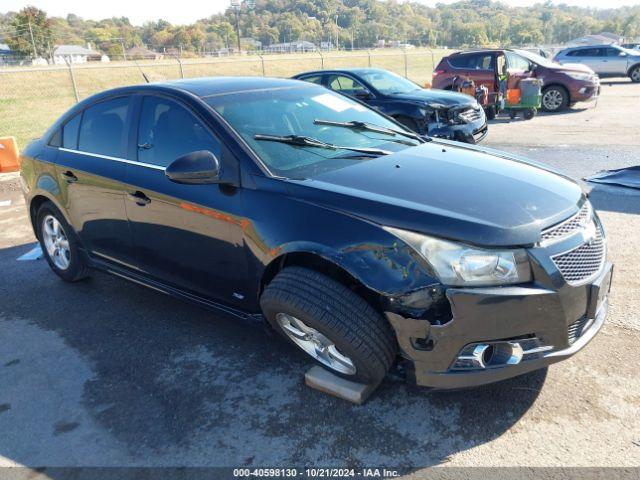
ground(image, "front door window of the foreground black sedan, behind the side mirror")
xmin=138 ymin=97 xmax=220 ymax=167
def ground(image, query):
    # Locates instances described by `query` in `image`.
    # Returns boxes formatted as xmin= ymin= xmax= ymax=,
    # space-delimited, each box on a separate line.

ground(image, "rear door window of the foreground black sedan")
xmin=78 ymin=97 xmax=129 ymax=158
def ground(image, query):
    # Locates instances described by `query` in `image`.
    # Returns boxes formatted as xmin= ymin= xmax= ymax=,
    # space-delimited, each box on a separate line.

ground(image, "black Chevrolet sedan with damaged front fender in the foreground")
xmin=21 ymin=78 xmax=611 ymax=388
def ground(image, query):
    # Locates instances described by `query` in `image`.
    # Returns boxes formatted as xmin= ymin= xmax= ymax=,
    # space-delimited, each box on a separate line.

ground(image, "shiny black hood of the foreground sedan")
xmin=288 ymin=142 xmax=583 ymax=246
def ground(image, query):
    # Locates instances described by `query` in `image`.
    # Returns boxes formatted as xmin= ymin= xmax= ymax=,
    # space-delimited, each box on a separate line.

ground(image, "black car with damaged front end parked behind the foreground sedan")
xmin=293 ymin=68 xmax=488 ymax=143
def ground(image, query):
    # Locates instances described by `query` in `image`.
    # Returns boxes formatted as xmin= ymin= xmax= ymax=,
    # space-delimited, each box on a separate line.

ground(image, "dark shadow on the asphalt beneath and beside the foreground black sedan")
xmin=0 ymin=244 xmax=546 ymax=471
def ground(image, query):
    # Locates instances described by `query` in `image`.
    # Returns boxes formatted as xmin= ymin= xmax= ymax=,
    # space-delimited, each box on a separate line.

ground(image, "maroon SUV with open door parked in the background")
xmin=432 ymin=49 xmax=600 ymax=113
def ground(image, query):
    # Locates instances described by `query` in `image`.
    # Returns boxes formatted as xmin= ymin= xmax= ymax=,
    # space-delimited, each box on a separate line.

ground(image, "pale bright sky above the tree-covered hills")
xmin=0 ymin=0 xmax=640 ymax=25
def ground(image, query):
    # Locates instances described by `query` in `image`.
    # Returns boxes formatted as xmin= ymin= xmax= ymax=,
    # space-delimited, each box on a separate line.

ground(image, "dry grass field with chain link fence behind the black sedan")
xmin=0 ymin=49 xmax=446 ymax=147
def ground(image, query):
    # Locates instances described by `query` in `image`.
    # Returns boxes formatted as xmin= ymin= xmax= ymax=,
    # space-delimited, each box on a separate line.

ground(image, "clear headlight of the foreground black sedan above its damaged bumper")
xmin=384 ymin=227 xmax=531 ymax=286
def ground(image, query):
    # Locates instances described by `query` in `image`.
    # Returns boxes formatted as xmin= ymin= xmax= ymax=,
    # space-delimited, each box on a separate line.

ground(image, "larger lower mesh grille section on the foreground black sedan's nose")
xmin=551 ymin=222 xmax=606 ymax=285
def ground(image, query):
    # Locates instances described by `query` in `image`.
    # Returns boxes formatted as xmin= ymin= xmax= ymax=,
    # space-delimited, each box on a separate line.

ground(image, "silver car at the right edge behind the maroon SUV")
xmin=555 ymin=45 xmax=640 ymax=83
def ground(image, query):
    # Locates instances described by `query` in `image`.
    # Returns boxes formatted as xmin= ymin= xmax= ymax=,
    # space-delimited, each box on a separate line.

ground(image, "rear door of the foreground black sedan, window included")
xmin=56 ymin=96 xmax=132 ymax=266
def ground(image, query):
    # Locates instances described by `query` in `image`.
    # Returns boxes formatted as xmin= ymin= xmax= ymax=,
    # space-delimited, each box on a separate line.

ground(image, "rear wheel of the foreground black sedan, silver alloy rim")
xmin=36 ymin=202 xmax=90 ymax=282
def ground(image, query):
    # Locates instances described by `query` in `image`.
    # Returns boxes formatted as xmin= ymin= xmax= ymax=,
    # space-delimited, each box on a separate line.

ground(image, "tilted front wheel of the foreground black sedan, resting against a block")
xmin=260 ymin=267 xmax=397 ymax=384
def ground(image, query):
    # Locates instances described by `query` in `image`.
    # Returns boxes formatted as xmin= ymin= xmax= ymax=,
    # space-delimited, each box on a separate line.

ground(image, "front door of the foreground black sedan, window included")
xmin=126 ymin=96 xmax=246 ymax=304
